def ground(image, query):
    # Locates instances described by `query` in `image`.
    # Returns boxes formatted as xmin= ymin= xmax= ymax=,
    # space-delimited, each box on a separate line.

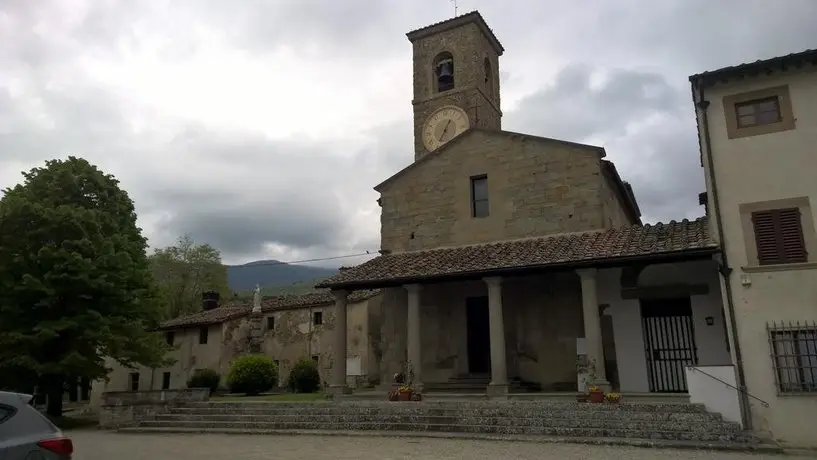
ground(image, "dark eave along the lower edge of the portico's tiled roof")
xmin=322 ymin=245 xmax=720 ymax=290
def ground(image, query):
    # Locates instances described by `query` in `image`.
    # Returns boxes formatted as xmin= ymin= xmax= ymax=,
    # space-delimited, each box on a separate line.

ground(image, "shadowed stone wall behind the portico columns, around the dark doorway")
xmin=381 ymin=272 xmax=584 ymax=390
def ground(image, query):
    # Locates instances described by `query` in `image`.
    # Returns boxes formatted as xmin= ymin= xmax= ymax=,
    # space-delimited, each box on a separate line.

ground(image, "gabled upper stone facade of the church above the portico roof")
xmin=380 ymin=131 xmax=605 ymax=252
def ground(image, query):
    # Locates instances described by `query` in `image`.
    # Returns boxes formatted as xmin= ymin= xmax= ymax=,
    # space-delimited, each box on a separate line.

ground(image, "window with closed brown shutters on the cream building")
xmin=752 ymin=208 xmax=808 ymax=265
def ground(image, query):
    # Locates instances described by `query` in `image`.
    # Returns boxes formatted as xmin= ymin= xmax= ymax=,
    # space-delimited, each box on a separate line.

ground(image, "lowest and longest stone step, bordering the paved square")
xmin=117 ymin=427 xmax=784 ymax=454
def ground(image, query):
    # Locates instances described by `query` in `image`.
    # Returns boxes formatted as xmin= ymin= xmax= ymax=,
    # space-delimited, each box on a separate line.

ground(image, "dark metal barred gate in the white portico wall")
xmin=641 ymin=297 xmax=698 ymax=393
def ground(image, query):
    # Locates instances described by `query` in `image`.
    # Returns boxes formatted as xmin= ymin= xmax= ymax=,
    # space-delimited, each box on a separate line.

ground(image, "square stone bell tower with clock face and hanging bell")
xmin=407 ymin=11 xmax=505 ymax=160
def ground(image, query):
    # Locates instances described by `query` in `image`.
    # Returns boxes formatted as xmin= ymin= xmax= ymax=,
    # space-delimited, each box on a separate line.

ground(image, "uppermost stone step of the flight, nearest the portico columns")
xmin=178 ymin=400 xmax=707 ymax=414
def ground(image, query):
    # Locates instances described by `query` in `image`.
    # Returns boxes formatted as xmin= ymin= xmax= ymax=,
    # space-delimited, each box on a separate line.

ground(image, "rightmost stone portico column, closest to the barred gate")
xmin=576 ymin=268 xmax=610 ymax=391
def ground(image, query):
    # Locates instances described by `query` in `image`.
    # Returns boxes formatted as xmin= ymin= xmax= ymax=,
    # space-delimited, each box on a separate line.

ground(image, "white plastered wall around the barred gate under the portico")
xmin=598 ymin=261 xmax=731 ymax=393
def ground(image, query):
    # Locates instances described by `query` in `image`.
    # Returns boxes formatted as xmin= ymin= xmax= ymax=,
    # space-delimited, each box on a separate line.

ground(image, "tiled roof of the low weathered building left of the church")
xmin=159 ymin=289 xmax=380 ymax=330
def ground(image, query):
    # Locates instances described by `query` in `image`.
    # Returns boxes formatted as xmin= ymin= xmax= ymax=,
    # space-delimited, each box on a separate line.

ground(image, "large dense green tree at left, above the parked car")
xmin=0 ymin=157 xmax=167 ymax=416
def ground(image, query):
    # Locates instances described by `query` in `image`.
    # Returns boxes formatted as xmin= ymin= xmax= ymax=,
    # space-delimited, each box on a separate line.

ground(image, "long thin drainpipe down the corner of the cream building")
xmin=692 ymin=80 xmax=752 ymax=430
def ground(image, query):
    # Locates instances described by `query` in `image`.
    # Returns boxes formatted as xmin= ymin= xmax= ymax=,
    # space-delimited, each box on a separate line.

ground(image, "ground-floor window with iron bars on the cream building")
xmin=767 ymin=322 xmax=817 ymax=394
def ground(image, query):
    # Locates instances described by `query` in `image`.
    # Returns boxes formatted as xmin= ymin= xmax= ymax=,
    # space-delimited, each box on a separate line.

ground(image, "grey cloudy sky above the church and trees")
xmin=0 ymin=0 xmax=817 ymax=265
